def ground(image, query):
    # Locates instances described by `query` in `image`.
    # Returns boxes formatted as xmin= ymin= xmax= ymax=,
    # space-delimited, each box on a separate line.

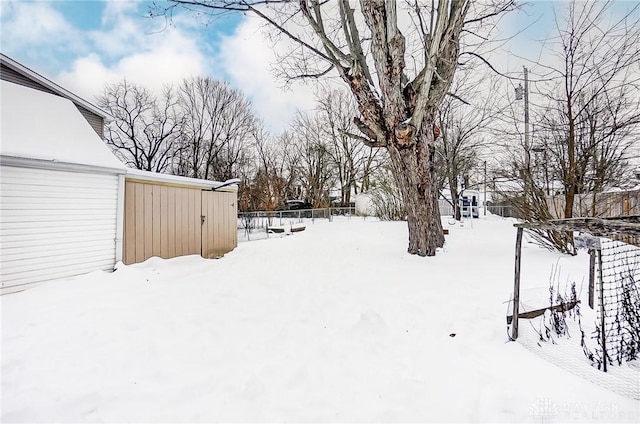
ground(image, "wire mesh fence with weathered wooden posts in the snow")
xmin=507 ymin=217 xmax=640 ymax=400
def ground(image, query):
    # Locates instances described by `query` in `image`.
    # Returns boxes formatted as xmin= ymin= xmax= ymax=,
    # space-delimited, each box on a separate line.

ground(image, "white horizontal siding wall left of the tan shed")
xmin=0 ymin=166 xmax=118 ymax=293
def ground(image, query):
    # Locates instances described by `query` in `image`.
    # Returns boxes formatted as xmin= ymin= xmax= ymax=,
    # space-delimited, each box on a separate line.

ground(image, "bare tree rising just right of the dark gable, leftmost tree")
xmin=98 ymin=80 xmax=182 ymax=172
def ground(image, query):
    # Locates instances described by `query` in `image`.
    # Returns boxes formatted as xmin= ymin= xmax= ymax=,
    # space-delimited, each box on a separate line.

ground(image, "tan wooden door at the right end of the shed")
xmin=201 ymin=190 xmax=238 ymax=259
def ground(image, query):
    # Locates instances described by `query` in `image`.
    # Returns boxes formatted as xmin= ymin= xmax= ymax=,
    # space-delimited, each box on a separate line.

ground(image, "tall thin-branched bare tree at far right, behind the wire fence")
xmin=540 ymin=1 xmax=640 ymax=222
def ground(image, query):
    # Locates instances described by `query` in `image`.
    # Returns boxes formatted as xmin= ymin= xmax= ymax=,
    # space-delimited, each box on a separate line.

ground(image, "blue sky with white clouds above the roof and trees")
xmin=0 ymin=0 xmax=636 ymax=131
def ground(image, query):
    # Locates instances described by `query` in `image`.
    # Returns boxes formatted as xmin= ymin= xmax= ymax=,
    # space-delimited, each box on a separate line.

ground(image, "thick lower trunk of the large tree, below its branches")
xmin=389 ymin=125 xmax=444 ymax=256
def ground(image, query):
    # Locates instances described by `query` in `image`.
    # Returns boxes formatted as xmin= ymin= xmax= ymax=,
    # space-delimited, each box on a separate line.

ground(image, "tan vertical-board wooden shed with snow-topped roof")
xmin=123 ymin=170 xmax=238 ymax=264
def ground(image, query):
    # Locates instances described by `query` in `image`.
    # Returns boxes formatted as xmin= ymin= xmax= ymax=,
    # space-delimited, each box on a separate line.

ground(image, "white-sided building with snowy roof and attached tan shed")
xmin=0 ymin=55 xmax=237 ymax=294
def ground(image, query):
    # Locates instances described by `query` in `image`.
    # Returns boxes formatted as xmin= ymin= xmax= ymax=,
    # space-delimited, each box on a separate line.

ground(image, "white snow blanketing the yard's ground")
xmin=0 ymin=217 xmax=640 ymax=423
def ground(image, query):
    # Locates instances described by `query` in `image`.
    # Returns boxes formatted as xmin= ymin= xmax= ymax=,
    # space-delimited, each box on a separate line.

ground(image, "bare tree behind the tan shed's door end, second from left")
xmin=178 ymin=77 xmax=256 ymax=181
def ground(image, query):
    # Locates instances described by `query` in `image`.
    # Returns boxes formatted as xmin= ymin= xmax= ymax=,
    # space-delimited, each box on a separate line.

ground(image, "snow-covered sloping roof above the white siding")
xmin=0 ymin=81 xmax=126 ymax=169
